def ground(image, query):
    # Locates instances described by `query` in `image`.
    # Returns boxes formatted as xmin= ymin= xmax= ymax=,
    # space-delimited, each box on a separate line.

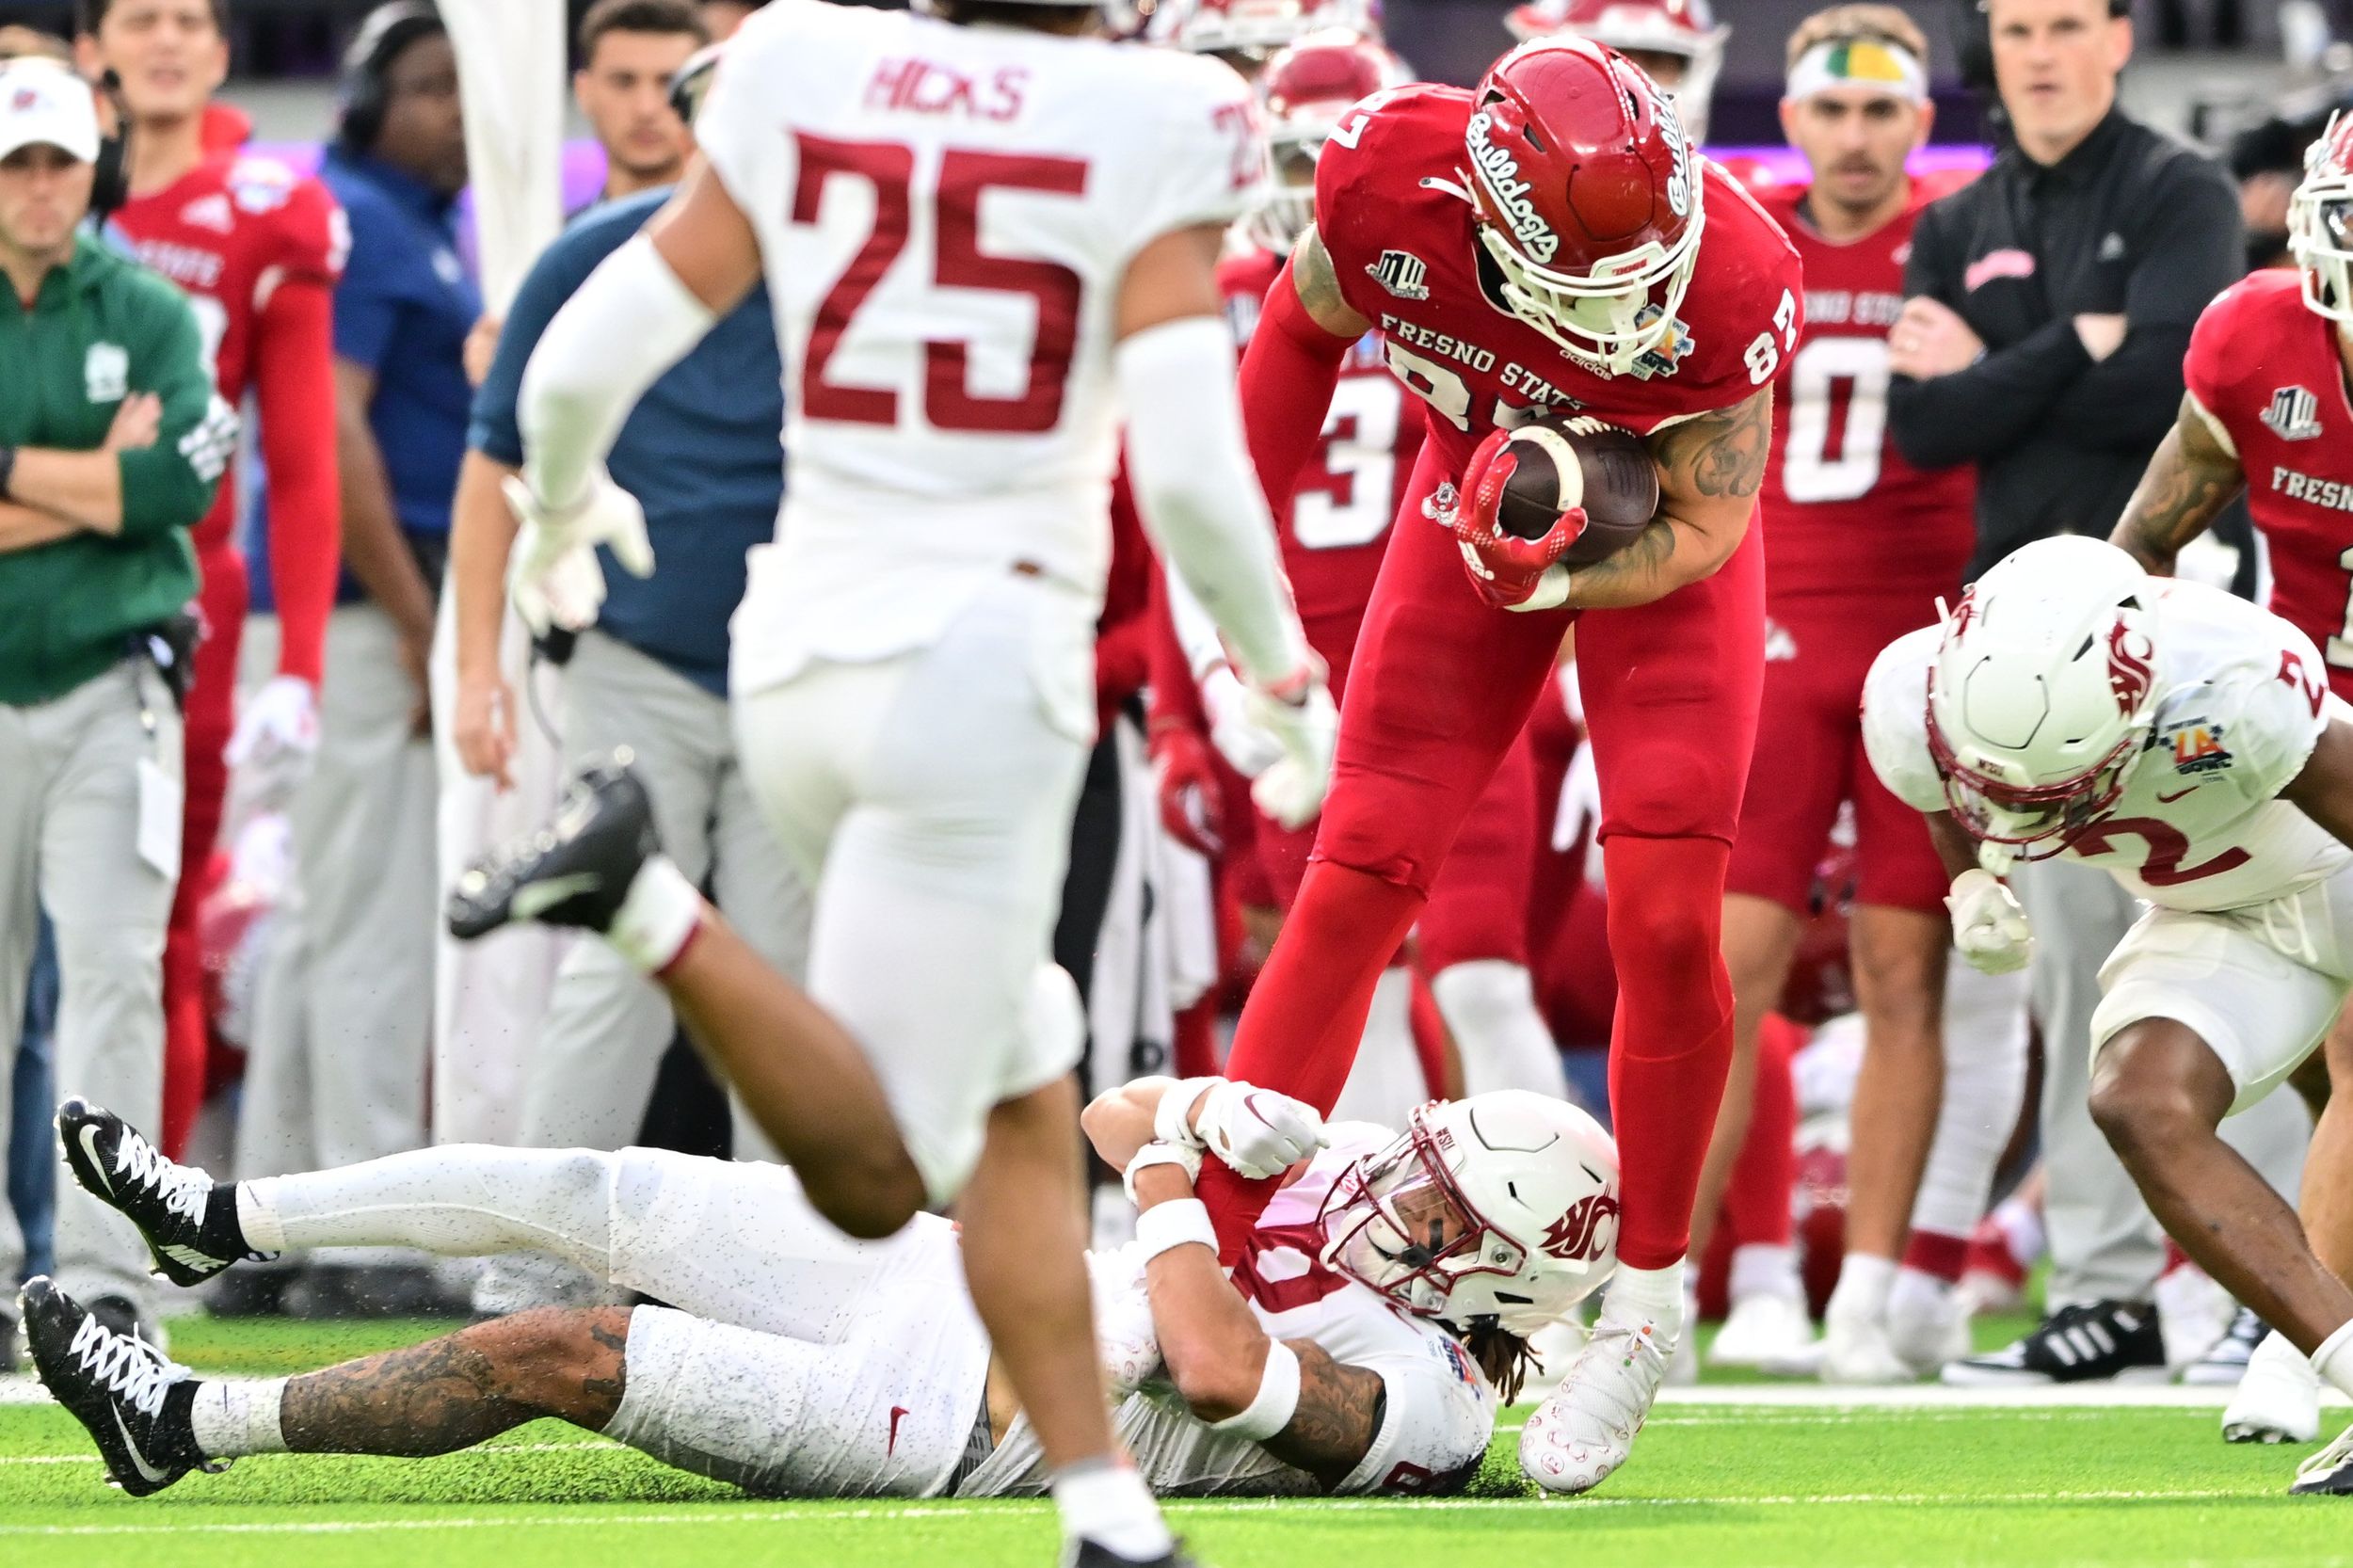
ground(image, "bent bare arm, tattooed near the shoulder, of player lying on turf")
xmin=1137 ymin=1165 xmax=1388 ymax=1488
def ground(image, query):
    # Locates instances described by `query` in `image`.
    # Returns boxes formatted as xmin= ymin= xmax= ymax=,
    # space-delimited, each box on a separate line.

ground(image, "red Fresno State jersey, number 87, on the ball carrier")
xmin=1316 ymin=85 xmax=1802 ymax=473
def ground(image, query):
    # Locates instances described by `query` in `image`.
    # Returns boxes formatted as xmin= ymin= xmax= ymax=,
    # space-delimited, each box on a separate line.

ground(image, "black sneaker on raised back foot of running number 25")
xmin=447 ymin=746 xmax=662 ymax=942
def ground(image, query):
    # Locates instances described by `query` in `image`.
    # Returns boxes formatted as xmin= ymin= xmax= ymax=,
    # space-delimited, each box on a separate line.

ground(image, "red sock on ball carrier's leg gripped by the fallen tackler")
xmin=1200 ymin=859 xmax=1424 ymax=1264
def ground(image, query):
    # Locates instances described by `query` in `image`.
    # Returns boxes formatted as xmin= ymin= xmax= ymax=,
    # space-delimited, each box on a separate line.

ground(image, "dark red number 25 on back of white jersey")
xmin=793 ymin=132 xmax=1087 ymax=436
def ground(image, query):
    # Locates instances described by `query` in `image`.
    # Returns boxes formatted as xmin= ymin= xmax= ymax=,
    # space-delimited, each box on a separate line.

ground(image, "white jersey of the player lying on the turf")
xmin=958 ymin=1121 xmax=1497 ymax=1497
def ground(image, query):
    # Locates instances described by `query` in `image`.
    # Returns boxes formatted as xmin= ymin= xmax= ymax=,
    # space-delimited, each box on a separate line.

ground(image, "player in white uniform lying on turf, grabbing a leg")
xmin=24 ymin=1079 xmax=1619 ymax=1497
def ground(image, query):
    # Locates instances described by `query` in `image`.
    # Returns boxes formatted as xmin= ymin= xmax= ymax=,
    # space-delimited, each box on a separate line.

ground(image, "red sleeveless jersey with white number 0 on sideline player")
xmin=1760 ymin=184 xmax=1977 ymax=607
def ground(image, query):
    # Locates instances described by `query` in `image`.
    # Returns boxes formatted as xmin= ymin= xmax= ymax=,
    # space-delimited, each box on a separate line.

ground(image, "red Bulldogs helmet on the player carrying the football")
xmin=1464 ymin=38 xmax=1706 ymax=376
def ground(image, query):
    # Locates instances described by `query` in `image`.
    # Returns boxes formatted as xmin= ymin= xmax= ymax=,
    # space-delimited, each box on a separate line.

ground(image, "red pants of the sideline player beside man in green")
xmin=160 ymin=544 xmax=248 ymax=1156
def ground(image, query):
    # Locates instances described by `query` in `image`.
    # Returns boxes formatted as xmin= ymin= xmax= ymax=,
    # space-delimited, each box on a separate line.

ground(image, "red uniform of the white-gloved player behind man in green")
xmin=113 ymin=151 xmax=351 ymax=1149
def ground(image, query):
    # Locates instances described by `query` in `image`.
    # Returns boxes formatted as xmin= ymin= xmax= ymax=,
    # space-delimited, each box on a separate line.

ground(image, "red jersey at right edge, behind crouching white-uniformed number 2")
xmin=2182 ymin=268 xmax=2353 ymax=699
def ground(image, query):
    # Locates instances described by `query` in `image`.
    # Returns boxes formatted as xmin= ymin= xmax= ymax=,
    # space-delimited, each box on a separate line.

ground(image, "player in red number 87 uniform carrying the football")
xmin=1212 ymin=40 xmax=1801 ymax=1490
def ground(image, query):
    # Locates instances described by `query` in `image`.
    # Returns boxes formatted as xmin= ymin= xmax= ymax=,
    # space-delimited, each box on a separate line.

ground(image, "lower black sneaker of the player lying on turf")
xmin=17 ymin=1273 xmax=226 ymax=1497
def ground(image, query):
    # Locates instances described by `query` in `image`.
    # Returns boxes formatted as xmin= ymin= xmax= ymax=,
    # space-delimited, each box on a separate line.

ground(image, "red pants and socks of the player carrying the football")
xmin=1203 ymin=447 xmax=1765 ymax=1269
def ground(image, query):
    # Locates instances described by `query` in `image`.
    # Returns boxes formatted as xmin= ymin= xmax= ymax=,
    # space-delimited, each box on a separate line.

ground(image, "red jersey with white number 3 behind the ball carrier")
xmin=1217 ymin=249 xmax=1424 ymax=621
